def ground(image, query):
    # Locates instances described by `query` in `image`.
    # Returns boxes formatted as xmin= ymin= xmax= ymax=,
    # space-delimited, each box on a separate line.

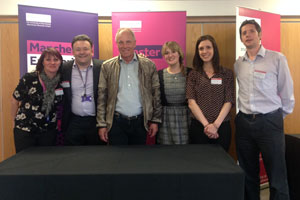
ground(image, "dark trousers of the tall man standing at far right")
xmin=235 ymin=109 xmax=290 ymax=200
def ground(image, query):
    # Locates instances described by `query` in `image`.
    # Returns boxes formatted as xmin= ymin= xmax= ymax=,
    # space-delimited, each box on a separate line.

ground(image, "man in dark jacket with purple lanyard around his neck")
xmin=62 ymin=35 xmax=102 ymax=145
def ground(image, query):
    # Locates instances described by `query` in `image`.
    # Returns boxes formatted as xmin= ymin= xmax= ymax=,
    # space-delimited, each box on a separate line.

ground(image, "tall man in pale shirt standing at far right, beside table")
xmin=234 ymin=20 xmax=295 ymax=200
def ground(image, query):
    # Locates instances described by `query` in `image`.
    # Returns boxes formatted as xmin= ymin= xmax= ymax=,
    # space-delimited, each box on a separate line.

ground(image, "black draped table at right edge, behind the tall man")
xmin=285 ymin=134 xmax=300 ymax=200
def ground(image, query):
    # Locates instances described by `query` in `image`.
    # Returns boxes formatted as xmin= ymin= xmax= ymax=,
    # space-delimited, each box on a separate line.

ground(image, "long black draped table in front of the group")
xmin=0 ymin=145 xmax=244 ymax=200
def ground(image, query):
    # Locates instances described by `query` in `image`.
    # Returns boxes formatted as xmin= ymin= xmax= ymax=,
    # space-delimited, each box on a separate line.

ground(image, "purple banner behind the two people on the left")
xmin=18 ymin=5 xmax=99 ymax=76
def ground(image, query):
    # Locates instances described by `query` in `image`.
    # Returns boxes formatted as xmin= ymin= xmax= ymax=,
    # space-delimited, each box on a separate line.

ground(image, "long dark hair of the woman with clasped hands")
xmin=193 ymin=35 xmax=220 ymax=73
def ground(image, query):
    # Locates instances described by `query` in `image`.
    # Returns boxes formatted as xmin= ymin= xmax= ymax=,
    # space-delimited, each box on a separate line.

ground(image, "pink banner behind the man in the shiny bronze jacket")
xmin=112 ymin=11 xmax=186 ymax=70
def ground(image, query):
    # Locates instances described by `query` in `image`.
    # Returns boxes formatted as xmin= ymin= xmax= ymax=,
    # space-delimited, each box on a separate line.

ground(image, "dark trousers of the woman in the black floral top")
xmin=14 ymin=128 xmax=57 ymax=153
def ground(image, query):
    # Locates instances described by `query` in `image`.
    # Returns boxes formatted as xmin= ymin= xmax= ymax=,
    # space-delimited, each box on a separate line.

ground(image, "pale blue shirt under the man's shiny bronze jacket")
xmin=116 ymin=54 xmax=143 ymax=117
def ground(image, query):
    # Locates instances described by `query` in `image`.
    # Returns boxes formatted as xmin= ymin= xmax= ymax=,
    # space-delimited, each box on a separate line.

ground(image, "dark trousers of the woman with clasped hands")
xmin=190 ymin=119 xmax=231 ymax=152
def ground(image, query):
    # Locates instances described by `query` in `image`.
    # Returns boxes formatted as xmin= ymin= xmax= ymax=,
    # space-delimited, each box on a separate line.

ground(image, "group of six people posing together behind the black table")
xmin=12 ymin=20 xmax=295 ymax=199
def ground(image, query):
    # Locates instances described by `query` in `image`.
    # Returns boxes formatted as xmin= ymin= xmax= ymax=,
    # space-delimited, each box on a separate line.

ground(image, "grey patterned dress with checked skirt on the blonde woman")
xmin=157 ymin=69 xmax=190 ymax=144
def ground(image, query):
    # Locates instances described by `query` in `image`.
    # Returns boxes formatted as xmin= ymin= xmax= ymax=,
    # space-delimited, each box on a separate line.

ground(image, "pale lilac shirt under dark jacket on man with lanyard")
xmin=71 ymin=61 xmax=96 ymax=117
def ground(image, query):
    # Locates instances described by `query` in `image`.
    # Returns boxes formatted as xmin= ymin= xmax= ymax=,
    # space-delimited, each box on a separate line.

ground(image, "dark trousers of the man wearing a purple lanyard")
xmin=65 ymin=115 xmax=104 ymax=145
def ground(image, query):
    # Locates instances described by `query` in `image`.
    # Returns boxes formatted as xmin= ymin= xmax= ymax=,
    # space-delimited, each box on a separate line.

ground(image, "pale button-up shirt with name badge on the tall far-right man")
xmin=234 ymin=46 xmax=295 ymax=117
